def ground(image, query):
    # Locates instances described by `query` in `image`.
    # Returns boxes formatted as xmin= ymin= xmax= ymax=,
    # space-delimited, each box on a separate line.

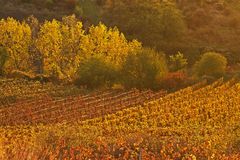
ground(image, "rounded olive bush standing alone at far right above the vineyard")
xmin=194 ymin=52 xmax=227 ymax=78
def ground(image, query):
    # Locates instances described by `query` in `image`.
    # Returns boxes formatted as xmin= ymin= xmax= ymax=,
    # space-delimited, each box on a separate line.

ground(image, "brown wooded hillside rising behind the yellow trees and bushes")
xmin=0 ymin=0 xmax=240 ymax=64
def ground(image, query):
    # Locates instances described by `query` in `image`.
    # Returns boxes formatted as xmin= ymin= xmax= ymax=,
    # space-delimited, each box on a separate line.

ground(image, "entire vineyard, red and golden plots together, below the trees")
xmin=0 ymin=79 xmax=240 ymax=160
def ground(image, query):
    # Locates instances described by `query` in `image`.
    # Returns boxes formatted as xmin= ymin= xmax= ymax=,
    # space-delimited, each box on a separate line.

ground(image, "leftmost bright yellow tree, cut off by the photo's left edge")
xmin=0 ymin=18 xmax=31 ymax=72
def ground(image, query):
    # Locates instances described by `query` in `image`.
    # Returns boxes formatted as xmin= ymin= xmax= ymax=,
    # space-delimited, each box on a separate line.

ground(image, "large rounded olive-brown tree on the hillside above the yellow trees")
xmin=103 ymin=0 xmax=186 ymax=48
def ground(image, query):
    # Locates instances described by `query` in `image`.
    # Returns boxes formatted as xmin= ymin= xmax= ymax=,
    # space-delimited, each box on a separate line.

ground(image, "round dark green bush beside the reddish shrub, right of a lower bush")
xmin=121 ymin=49 xmax=168 ymax=89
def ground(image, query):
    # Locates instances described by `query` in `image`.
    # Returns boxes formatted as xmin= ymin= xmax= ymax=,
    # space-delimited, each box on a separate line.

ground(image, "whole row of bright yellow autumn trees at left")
xmin=0 ymin=16 xmax=141 ymax=80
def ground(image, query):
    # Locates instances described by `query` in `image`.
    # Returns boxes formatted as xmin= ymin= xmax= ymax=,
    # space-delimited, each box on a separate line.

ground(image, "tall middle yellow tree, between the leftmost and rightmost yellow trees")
xmin=36 ymin=16 xmax=84 ymax=79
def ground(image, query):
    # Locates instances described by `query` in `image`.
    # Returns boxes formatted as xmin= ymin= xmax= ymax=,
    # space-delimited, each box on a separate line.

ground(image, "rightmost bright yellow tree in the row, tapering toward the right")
xmin=81 ymin=23 xmax=141 ymax=67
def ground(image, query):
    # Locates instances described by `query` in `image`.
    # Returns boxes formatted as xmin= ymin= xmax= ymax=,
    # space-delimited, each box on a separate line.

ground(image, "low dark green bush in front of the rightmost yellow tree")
xmin=75 ymin=57 xmax=117 ymax=89
